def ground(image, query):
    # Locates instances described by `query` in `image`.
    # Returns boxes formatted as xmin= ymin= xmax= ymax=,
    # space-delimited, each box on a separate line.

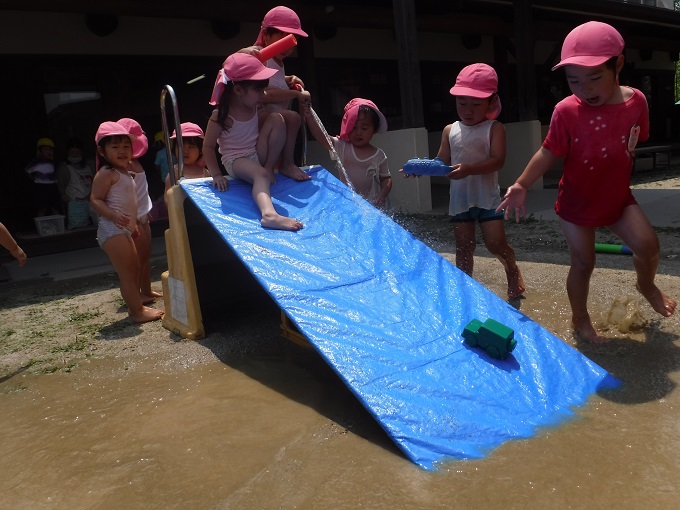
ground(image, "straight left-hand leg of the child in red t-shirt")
xmin=560 ymin=219 xmax=608 ymax=343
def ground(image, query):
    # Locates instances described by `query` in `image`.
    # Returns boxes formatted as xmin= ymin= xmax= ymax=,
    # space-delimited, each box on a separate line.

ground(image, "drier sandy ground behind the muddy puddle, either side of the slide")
xmin=0 ymin=168 xmax=680 ymax=382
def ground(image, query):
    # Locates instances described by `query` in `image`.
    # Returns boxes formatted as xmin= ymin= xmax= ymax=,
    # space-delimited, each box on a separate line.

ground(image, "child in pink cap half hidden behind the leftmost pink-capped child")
xmin=118 ymin=118 xmax=163 ymax=305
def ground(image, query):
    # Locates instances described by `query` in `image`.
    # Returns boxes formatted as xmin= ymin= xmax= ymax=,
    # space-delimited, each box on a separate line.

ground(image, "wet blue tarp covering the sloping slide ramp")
xmin=181 ymin=167 xmax=616 ymax=469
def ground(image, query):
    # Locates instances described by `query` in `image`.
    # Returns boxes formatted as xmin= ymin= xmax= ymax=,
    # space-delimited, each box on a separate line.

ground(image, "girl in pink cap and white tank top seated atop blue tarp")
xmin=203 ymin=53 xmax=302 ymax=230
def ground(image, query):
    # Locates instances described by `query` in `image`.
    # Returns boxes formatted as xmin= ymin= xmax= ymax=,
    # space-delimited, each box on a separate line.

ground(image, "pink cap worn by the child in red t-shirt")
xmin=552 ymin=21 xmax=625 ymax=71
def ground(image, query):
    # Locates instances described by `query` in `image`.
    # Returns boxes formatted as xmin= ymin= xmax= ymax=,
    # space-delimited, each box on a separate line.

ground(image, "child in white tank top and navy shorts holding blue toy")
xmin=437 ymin=64 xmax=525 ymax=298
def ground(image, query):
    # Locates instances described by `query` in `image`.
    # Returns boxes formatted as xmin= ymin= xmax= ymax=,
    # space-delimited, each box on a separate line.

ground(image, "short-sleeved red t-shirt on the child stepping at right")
xmin=543 ymin=89 xmax=649 ymax=227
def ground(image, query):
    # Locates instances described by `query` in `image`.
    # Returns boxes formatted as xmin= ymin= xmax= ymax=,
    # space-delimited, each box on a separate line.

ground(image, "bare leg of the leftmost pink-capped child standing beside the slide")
xmin=104 ymin=234 xmax=163 ymax=322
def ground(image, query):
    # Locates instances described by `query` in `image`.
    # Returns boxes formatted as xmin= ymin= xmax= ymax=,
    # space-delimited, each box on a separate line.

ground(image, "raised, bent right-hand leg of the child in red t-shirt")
xmin=609 ymin=204 xmax=677 ymax=317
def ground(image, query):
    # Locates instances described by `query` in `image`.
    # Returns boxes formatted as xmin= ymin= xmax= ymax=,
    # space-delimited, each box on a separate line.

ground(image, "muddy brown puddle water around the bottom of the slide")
xmin=0 ymin=268 xmax=680 ymax=510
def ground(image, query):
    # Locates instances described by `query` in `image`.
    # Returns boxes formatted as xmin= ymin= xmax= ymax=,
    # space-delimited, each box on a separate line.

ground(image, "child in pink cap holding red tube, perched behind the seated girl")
xmin=241 ymin=5 xmax=311 ymax=181
